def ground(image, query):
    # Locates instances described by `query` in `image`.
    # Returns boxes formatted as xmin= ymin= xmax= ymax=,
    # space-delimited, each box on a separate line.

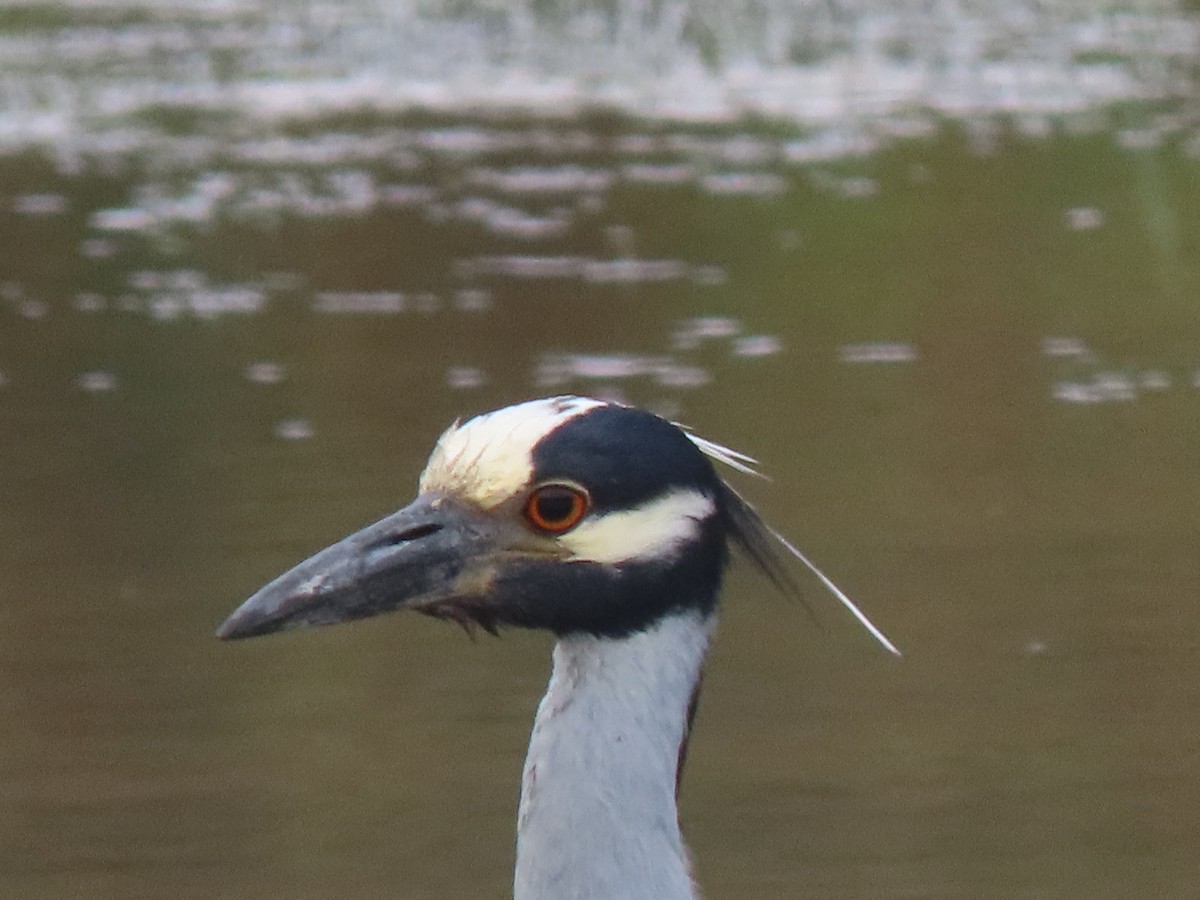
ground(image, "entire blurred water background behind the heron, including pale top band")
xmin=0 ymin=0 xmax=1200 ymax=900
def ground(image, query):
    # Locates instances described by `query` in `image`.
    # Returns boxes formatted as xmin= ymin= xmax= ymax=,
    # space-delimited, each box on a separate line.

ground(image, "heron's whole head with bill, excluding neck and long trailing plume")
xmin=217 ymin=397 xmax=781 ymax=638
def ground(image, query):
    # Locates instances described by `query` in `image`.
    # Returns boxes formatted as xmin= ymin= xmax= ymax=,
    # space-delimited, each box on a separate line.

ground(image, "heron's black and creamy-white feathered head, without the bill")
xmin=420 ymin=397 xmax=782 ymax=636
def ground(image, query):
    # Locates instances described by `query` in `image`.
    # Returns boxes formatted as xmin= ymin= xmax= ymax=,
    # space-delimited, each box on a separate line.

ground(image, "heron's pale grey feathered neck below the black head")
xmin=514 ymin=612 xmax=715 ymax=900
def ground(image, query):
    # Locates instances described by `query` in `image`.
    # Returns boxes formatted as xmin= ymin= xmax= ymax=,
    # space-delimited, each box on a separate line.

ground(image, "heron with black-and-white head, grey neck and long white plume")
xmin=217 ymin=396 xmax=899 ymax=900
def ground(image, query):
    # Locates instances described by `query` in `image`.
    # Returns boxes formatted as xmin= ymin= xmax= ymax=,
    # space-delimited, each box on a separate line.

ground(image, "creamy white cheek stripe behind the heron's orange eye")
xmin=558 ymin=488 xmax=716 ymax=563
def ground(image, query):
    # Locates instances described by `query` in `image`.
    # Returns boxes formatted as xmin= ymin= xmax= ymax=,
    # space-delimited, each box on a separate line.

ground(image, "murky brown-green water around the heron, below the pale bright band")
xmin=0 ymin=113 xmax=1200 ymax=900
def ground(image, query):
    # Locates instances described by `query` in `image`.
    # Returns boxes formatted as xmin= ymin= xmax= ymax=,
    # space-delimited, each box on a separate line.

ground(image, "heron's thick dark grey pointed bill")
xmin=217 ymin=494 xmax=547 ymax=640
